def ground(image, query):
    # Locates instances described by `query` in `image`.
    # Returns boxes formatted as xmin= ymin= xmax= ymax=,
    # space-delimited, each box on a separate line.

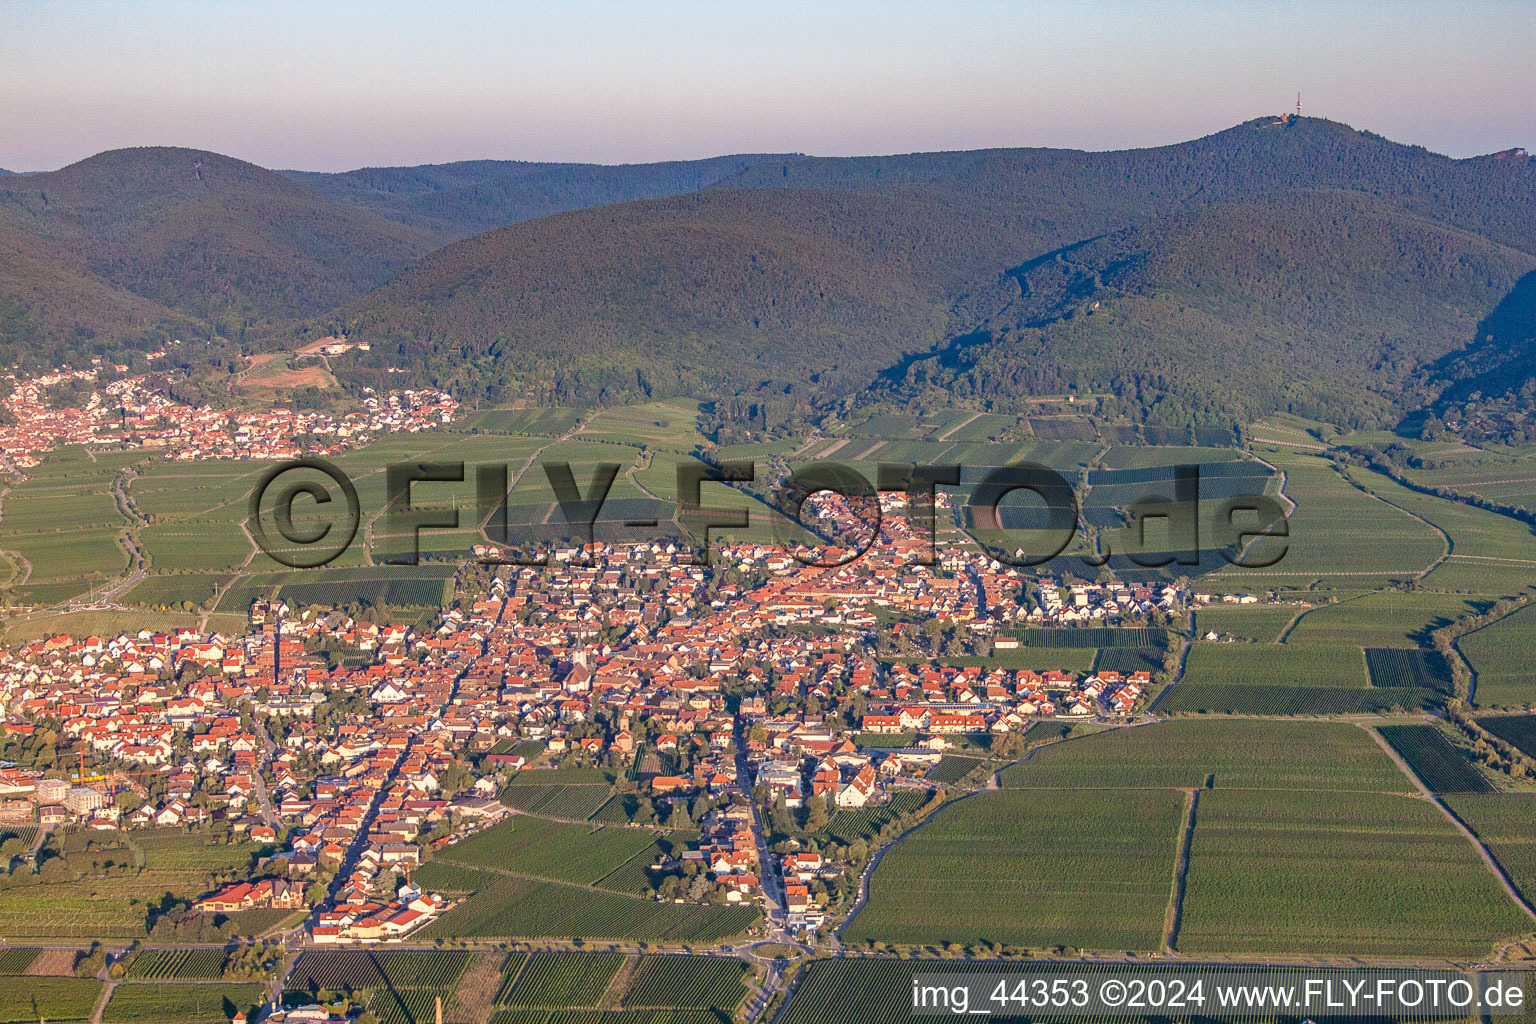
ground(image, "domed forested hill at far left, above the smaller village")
xmin=0 ymin=149 xmax=430 ymax=327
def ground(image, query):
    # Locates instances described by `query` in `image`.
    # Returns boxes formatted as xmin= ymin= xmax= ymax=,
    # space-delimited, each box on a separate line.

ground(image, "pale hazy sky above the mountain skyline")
xmin=0 ymin=0 xmax=1536 ymax=170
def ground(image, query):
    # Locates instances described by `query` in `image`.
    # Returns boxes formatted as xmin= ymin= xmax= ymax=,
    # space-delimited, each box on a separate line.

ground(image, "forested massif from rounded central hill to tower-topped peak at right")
xmin=324 ymin=118 xmax=1536 ymax=424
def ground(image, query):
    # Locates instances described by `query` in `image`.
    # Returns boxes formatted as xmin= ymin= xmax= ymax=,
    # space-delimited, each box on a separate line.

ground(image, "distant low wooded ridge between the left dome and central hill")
xmin=280 ymin=154 xmax=797 ymax=244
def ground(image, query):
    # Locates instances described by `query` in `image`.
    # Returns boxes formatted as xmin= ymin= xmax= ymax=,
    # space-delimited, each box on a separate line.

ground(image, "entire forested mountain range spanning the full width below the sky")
xmin=0 ymin=118 xmax=1536 ymax=433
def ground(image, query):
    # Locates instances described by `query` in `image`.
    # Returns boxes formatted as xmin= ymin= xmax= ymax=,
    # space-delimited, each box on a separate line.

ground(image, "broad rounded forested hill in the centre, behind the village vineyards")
xmin=312 ymin=190 xmax=1044 ymax=401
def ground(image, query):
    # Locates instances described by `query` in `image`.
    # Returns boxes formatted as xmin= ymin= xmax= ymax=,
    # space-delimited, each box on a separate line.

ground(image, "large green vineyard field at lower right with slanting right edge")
xmin=1177 ymin=789 xmax=1530 ymax=958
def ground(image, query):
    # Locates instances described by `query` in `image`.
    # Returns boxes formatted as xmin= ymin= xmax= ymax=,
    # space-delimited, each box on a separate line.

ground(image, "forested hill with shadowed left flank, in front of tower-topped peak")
xmin=869 ymin=190 xmax=1536 ymax=425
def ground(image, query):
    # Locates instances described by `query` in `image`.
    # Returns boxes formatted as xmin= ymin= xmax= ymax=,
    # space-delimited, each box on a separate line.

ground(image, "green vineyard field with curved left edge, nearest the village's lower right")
xmin=843 ymin=791 xmax=1184 ymax=949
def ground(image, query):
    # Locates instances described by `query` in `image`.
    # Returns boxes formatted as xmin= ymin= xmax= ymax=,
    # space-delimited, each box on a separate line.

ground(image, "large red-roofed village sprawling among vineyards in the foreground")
xmin=0 ymin=488 xmax=1186 ymax=944
